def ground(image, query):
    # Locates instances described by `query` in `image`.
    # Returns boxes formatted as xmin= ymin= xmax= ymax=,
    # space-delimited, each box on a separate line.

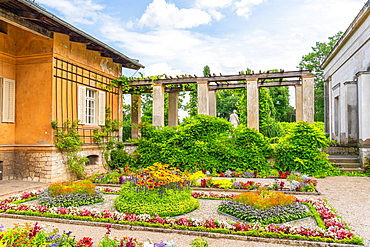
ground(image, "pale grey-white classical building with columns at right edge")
xmin=322 ymin=1 xmax=370 ymax=163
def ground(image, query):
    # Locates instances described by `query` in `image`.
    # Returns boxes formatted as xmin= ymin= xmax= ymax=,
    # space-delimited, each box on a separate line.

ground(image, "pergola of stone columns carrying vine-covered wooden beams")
xmin=125 ymin=70 xmax=314 ymax=139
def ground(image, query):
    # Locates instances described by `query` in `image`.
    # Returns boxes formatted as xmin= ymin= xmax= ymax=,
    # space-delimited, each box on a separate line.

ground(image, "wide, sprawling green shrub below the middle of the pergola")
xmin=136 ymin=115 xmax=271 ymax=173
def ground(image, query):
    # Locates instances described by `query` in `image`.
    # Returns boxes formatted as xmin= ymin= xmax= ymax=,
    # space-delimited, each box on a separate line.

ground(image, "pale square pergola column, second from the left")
xmin=152 ymin=83 xmax=164 ymax=126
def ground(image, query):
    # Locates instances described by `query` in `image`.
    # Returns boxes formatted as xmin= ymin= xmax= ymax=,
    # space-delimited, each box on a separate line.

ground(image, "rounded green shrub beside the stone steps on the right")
xmin=275 ymin=121 xmax=335 ymax=176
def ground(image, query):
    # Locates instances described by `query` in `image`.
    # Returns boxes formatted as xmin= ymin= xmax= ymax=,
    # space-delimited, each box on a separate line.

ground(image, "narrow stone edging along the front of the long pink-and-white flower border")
xmin=0 ymin=213 xmax=363 ymax=247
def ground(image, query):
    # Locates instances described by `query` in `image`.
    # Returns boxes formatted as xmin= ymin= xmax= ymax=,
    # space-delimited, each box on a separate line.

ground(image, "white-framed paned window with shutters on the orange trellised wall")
xmin=78 ymin=86 xmax=105 ymax=125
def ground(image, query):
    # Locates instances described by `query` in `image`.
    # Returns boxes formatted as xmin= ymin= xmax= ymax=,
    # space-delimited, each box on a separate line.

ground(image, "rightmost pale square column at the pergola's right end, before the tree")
xmin=302 ymin=75 xmax=315 ymax=123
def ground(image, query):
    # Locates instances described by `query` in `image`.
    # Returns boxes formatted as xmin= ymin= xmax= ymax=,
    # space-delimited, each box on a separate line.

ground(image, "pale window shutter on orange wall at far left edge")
xmin=2 ymin=78 xmax=15 ymax=123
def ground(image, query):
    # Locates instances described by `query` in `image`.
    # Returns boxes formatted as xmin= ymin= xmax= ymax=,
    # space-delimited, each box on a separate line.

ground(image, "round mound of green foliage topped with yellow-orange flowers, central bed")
xmin=115 ymin=163 xmax=199 ymax=216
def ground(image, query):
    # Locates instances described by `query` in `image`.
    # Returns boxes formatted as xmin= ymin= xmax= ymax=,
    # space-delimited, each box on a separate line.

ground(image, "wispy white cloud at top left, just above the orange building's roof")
xmin=37 ymin=0 xmax=104 ymax=24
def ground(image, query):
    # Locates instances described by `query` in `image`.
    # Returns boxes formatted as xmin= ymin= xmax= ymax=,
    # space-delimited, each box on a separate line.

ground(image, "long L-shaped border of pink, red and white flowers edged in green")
xmin=0 ymin=191 xmax=363 ymax=245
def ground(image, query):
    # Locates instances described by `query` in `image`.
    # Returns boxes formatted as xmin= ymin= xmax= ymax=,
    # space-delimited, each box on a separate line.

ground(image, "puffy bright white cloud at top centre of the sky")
xmin=138 ymin=0 xmax=212 ymax=29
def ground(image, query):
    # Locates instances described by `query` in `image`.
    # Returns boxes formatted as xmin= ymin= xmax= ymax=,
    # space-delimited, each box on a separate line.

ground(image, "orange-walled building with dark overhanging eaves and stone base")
xmin=0 ymin=0 xmax=143 ymax=182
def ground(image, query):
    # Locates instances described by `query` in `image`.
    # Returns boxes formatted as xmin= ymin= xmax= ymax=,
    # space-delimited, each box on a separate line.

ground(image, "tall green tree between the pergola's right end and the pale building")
xmin=299 ymin=32 xmax=343 ymax=122
